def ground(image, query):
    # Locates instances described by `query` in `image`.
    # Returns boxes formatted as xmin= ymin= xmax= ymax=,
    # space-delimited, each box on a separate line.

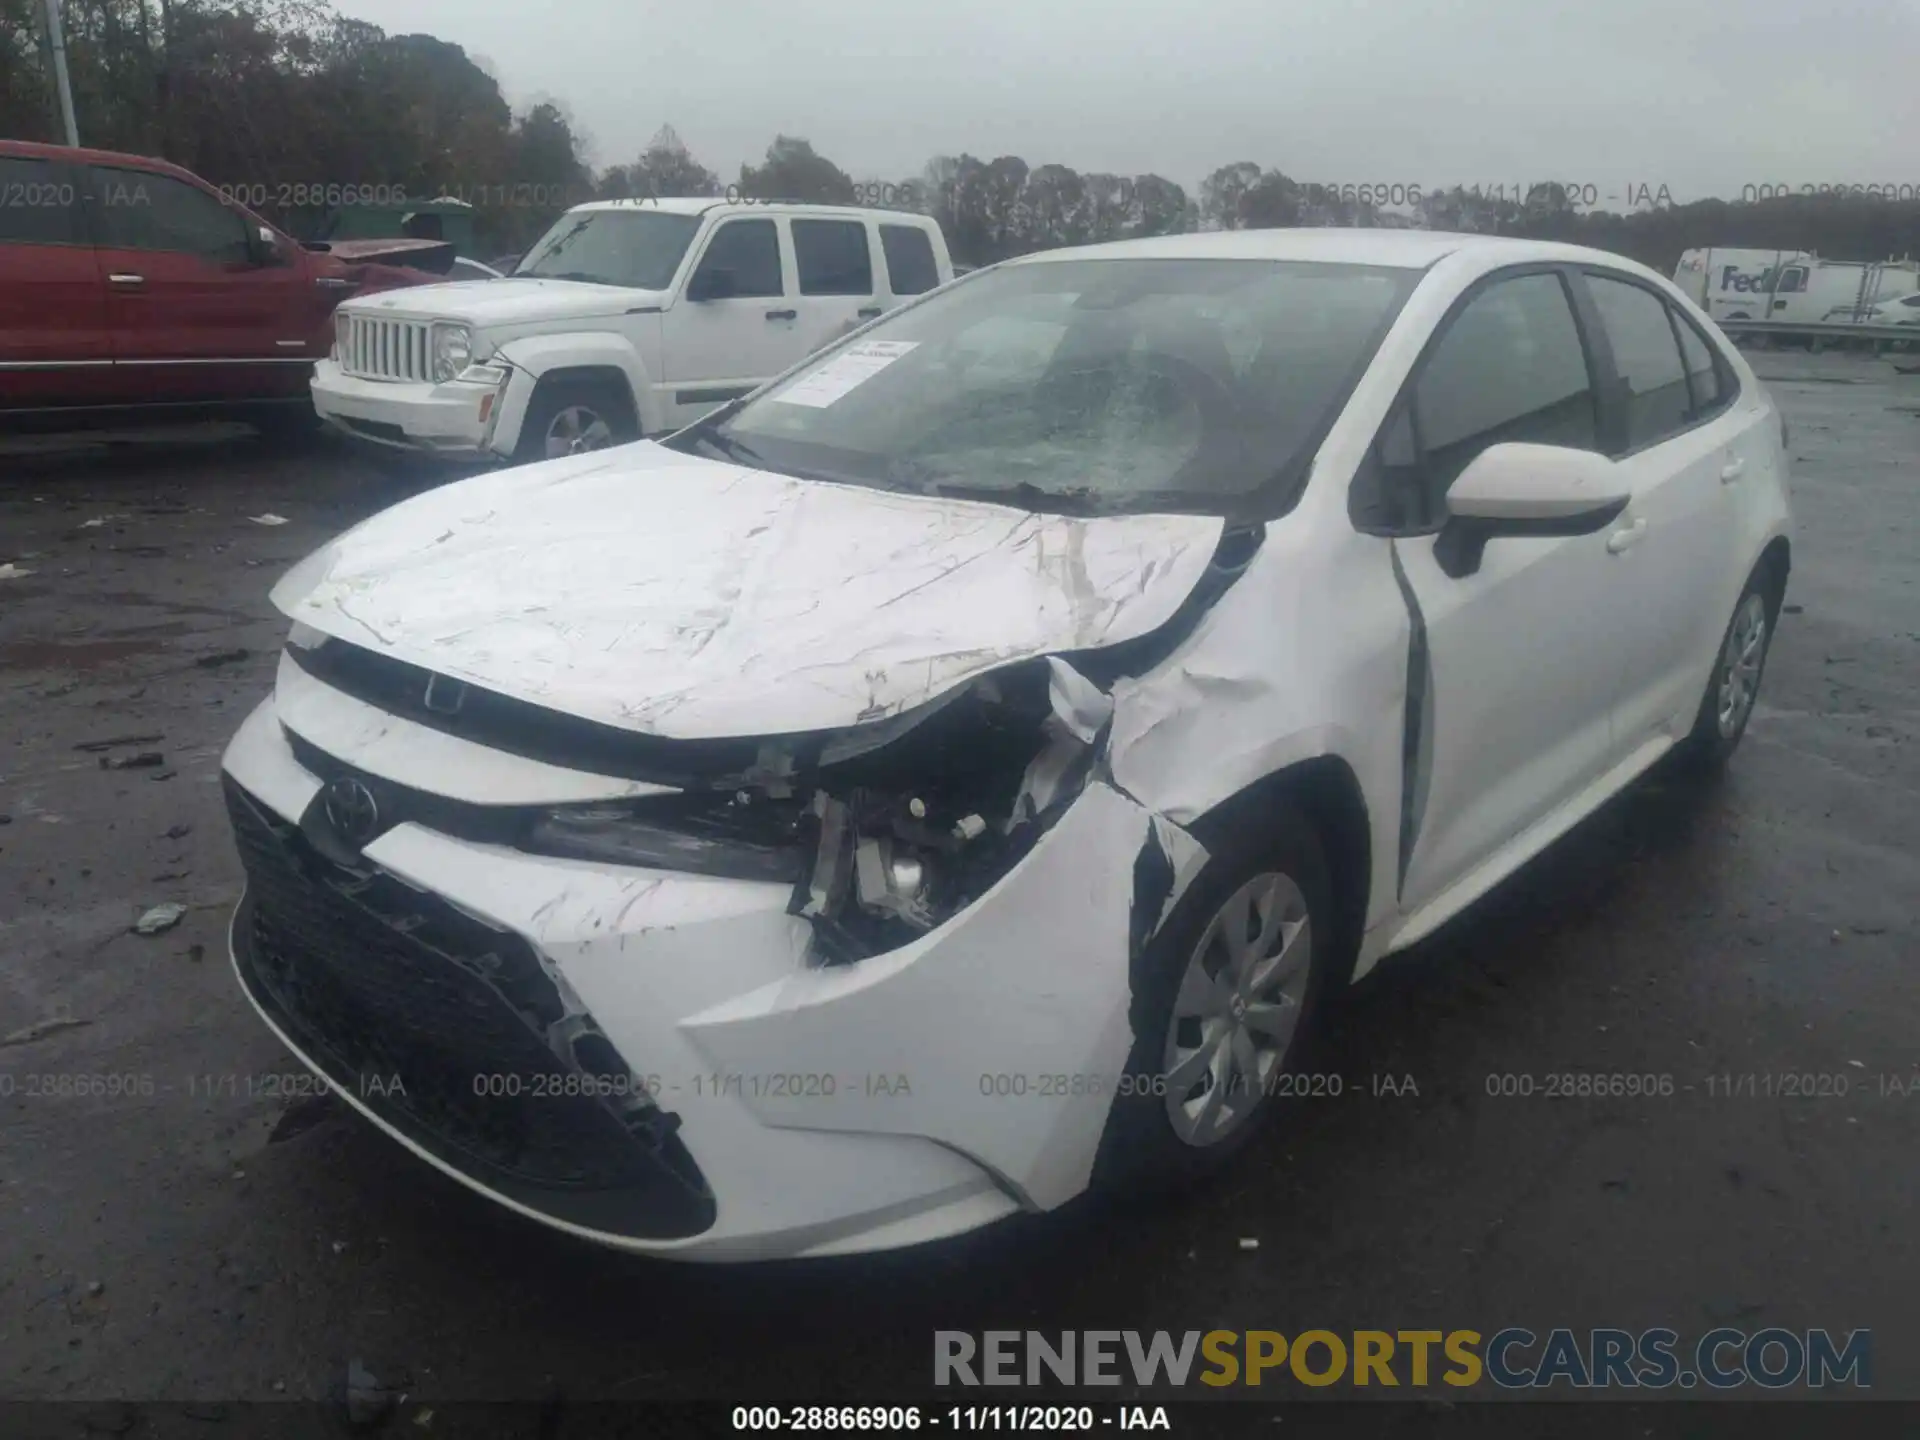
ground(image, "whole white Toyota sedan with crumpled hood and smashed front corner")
xmin=225 ymin=230 xmax=1789 ymax=1260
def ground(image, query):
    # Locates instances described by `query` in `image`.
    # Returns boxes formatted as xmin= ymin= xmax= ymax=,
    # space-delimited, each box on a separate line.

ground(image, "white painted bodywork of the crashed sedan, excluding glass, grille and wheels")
xmin=225 ymin=230 xmax=1791 ymax=1260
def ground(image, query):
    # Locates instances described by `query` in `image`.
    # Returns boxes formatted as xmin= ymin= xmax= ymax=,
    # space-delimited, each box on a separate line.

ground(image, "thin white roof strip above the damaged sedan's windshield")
xmin=1008 ymin=227 xmax=1642 ymax=271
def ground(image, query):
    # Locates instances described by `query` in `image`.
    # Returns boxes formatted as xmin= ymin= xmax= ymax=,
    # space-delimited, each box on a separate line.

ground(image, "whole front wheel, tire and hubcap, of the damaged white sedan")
xmin=1094 ymin=801 xmax=1338 ymax=1188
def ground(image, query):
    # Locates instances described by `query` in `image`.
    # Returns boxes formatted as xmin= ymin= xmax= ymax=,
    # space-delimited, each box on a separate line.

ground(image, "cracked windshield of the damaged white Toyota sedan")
xmin=676 ymin=259 xmax=1421 ymax=515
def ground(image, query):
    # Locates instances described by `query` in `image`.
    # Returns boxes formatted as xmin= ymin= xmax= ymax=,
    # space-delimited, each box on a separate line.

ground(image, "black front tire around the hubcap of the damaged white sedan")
xmin=1092 ymin=799 xmax=1348 ymax=1192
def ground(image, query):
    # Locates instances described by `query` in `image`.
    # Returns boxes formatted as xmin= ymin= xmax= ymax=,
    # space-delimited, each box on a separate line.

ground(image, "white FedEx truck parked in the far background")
xmin=1674 ymin=248 xmax=1920 ymax=324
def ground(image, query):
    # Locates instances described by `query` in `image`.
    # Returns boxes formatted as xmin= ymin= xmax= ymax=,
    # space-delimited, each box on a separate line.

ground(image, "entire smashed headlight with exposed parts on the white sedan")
xmin=516 ymin=659 xmax=1114 ymax=964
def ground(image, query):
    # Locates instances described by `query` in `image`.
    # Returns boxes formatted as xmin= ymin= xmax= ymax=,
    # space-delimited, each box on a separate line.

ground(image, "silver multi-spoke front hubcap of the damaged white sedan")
xmin=1162 ymin=874 xmax=1313 ymax=1144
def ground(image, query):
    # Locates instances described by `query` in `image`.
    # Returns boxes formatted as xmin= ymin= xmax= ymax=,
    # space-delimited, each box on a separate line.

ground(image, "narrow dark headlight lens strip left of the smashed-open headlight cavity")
xmin=522 ymin=797 xmax=806 ymax=885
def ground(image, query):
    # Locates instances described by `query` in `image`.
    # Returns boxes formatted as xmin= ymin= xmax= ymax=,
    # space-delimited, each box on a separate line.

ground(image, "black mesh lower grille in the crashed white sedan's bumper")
xmin=227 ymin=780 xmax=714 ymax=1238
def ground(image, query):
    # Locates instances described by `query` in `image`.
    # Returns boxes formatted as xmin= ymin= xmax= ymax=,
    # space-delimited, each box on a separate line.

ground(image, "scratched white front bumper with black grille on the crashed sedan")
xmin=225 ymin=701 xmax=1152 ymax=1260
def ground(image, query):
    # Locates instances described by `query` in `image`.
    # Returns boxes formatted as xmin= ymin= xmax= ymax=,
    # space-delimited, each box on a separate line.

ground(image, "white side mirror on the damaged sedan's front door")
xmin=1434 ymin=442 xmax=1632 ymax=578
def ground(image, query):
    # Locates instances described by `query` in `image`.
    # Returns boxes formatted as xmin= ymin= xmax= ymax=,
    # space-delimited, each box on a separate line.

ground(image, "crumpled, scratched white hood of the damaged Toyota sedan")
xmin=273 ymin=442 xmax=1223 ymax=739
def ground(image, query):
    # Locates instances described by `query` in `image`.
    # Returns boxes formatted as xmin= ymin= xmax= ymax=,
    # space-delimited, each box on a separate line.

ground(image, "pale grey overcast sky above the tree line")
xmin=336 ymin=0 xmax=1920 ymax=209
